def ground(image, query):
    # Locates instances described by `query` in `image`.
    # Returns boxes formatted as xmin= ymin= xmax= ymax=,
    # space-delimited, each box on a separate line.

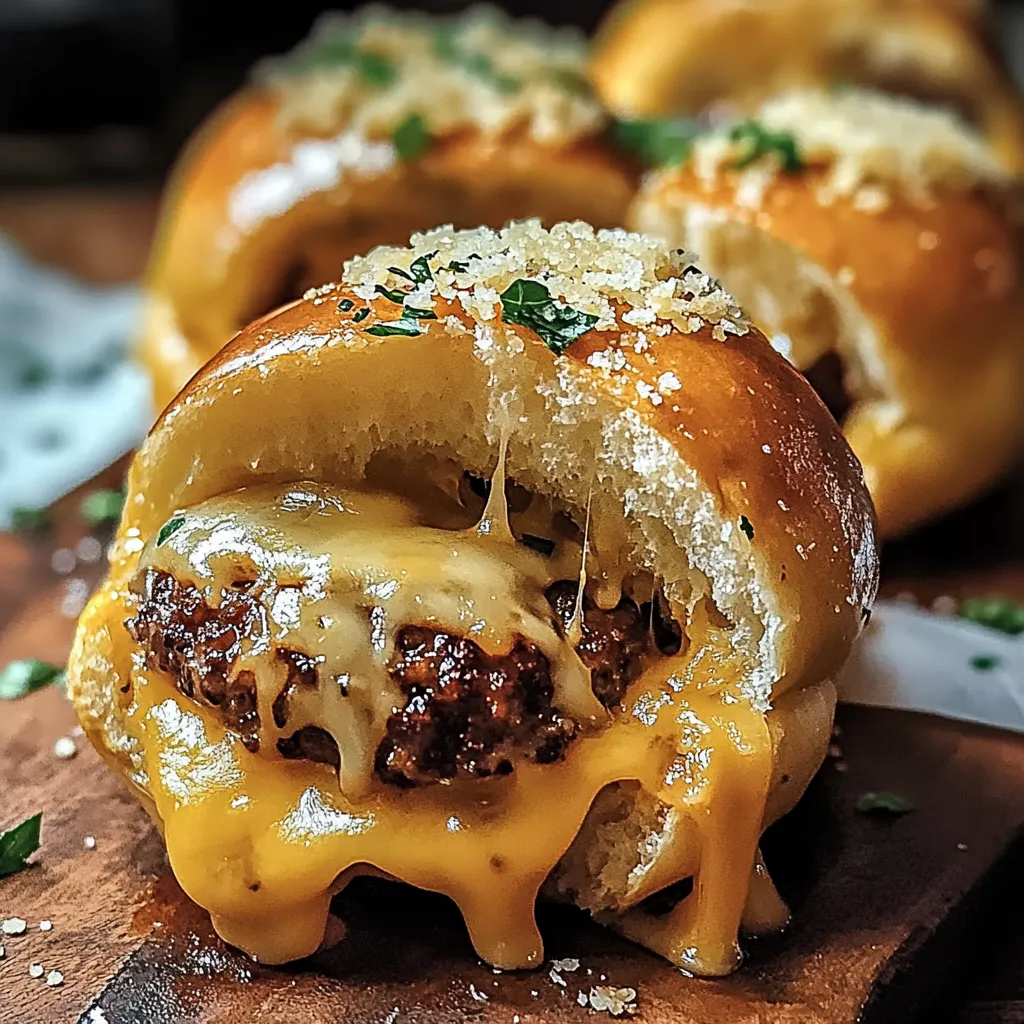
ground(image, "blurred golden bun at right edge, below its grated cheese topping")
xmin=631 ymin=133 xmax=1024 ymax=537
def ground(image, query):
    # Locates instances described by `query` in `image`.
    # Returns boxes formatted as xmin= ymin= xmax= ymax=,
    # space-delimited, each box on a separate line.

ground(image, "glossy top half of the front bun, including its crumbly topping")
xmin=128 ymin=222 xmax=878 ymax=705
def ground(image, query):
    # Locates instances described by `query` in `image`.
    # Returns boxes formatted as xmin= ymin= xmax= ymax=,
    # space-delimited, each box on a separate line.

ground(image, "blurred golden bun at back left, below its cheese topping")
xmin=141 ymin=13 xmax=636 ymax=409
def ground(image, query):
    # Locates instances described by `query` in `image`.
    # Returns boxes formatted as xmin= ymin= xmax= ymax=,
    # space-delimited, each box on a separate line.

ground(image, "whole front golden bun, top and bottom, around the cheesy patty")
xmin=70 ymin=222 xmax=878 ymax=974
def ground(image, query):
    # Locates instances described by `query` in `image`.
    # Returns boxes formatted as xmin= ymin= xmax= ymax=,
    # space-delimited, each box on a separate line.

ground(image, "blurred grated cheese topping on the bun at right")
xmin=693 ymin=89 xmax=1013 ymax=213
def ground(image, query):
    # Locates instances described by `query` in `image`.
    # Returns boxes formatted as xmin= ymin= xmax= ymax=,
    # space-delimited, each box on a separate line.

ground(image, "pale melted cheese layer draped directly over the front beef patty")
xmin=140 ymin=483 xmax=605 ymax=797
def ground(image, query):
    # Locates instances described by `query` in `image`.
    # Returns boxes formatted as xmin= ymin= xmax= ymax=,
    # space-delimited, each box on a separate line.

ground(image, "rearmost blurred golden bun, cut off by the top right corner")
xmin=591 ymin=0 xmax=1024 ymax=169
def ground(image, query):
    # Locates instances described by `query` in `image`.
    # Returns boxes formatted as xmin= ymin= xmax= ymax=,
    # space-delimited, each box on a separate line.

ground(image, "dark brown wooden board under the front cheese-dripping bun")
xmin=0 ymin=470 xmax=1024 ymax=1024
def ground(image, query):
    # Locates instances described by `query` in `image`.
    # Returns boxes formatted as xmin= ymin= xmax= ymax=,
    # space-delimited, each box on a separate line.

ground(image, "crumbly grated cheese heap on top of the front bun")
xmin=342 ymin=220 xmax=749 ymax=339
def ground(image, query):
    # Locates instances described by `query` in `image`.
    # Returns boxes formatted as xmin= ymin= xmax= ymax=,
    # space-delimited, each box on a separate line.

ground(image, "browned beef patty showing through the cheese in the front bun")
xmin=125 ymin=569 xmax=663 ymax=786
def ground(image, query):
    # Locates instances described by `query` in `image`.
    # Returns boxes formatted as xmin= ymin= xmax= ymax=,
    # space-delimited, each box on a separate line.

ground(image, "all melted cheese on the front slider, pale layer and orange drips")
xmin=105 ymin=484 xmax=772 ymax=975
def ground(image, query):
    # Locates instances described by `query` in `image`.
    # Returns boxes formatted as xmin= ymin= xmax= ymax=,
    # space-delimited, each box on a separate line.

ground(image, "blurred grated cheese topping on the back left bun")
xmin=256 ymin=5 xmax=605 ymax=142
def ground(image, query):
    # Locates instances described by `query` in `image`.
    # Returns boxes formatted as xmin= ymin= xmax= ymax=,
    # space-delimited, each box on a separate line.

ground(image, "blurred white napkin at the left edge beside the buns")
xmin=0 ymin=237 xmax=153 ymax=529
